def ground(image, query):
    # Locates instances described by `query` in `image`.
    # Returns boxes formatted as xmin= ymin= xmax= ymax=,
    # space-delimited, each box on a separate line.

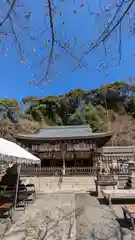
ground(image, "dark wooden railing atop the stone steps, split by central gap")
xmin=21 ymin=166 xmax=96 ymax=176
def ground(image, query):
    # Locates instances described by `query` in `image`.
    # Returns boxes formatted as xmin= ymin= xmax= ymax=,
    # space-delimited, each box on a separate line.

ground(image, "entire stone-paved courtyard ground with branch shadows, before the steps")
xmin=0 ymin=192 xmax=135 ymax=240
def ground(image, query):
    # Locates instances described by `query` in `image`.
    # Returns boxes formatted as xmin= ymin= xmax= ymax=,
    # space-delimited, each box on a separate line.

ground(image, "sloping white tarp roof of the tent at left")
xmin=0 ymin=138 xmax=40 ymax=164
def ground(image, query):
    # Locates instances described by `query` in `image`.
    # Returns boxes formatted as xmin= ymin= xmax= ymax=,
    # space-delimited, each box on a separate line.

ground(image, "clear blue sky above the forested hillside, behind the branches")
xmin=0 ymin=1 xmax=135 ymax=100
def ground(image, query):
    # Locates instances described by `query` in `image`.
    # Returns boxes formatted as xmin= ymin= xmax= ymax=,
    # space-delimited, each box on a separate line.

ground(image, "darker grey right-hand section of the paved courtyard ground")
xmin=75 ymin=194 xmax=135 ymax=240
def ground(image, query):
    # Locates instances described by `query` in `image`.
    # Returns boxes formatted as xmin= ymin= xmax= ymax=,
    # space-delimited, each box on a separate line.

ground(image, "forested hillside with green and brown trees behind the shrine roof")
xmin=0 ymin=81 xmax=135 ymax=145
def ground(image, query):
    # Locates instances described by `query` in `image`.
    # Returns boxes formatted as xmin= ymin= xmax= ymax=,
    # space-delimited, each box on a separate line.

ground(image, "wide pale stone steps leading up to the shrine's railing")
xmin=22 ymin=176 xmax=95 ymax=193
